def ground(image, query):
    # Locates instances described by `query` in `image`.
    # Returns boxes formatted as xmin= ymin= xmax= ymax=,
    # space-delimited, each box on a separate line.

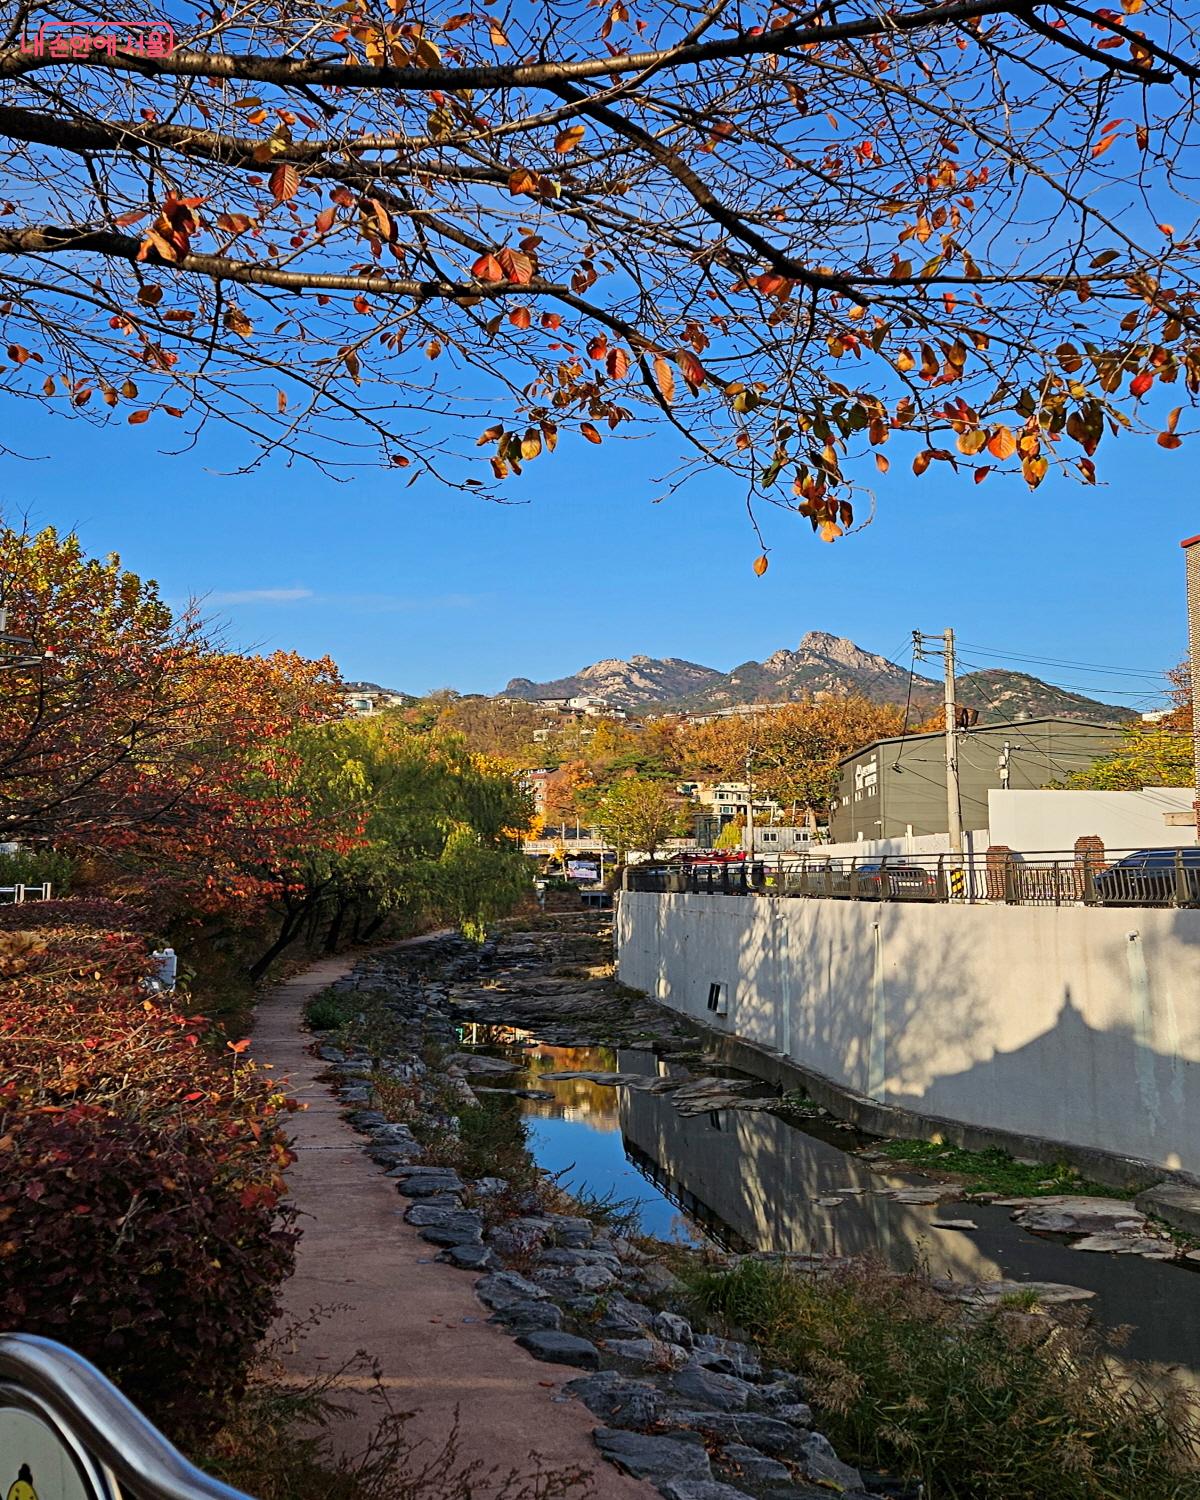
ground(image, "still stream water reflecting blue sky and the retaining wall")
xmin=464 ymin=1032 xmax=1200 ymax=1392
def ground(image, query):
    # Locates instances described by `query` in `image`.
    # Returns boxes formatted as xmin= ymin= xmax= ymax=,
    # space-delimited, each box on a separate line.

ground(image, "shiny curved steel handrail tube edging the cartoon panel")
xmin=0 ymin=1334 xmax=249 ymax=1500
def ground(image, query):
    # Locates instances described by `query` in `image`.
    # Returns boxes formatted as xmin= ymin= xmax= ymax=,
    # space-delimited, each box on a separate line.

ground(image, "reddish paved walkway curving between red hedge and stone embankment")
xmin=254 ymin=939 xmax=656 ymax=1500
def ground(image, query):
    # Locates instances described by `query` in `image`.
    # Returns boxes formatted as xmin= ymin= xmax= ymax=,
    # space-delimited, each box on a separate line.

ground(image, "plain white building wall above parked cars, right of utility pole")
xmin=987 ymin=786 xmax=1196 ymax=851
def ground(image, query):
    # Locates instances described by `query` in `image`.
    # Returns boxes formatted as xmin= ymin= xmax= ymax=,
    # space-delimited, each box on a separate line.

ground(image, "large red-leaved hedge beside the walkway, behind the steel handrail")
xmin=0 ymin=903 xmax=294 ymax=1437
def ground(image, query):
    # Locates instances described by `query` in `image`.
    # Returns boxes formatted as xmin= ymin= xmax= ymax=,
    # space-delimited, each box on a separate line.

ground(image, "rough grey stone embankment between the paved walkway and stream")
xmin=309 ymin=918 xmax=900 ymax=1500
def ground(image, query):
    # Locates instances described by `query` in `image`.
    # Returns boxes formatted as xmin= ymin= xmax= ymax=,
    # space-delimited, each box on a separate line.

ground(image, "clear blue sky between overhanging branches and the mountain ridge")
xmin=0 ymin=407 xmax=1200 ymax=707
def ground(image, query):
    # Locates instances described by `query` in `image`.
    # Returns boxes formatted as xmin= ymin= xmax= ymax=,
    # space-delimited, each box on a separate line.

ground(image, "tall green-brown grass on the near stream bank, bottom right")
xmin=690 ymin=1260 xmax=1200 ymax=1500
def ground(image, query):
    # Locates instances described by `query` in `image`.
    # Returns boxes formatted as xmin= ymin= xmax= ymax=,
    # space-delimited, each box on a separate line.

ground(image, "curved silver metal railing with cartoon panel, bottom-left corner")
xmin=0 ymin=1334 xmax=249 ymax=1500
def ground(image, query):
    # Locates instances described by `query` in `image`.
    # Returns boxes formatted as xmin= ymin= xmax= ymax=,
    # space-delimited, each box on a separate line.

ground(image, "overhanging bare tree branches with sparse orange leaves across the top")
xmin=0 ymin=0 xmax=1200 ymax=549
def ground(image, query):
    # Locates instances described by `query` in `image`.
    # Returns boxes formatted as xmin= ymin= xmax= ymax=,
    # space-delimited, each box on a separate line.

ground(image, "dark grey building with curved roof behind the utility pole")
xmin=830 ymin=719 xmax=1125 ymax=843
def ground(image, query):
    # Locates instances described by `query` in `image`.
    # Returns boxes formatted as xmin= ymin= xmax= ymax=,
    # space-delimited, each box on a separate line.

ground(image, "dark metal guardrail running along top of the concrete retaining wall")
xmin=624 ymin=848 xmax=1200 ymax=906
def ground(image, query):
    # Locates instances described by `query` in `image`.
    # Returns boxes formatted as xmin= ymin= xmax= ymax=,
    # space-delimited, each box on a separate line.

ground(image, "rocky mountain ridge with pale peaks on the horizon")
xmin=500 ymin=630 xmax=1133 ymax=723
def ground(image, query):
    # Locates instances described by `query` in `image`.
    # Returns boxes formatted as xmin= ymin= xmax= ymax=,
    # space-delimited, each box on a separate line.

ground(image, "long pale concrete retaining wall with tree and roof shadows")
xmin=617 ymin=891 xmax=1200 ymax=1173
